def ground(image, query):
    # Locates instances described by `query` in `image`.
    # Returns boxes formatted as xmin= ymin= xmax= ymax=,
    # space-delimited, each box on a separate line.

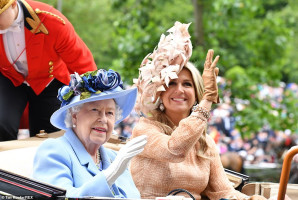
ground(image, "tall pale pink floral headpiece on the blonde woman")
xmin=134 ymin=21 xmax=192 ymax=115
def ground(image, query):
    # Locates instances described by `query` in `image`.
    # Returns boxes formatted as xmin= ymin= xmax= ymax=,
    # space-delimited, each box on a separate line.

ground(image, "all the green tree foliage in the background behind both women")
xmin=36 ymin=0 xmax=298 ymax=134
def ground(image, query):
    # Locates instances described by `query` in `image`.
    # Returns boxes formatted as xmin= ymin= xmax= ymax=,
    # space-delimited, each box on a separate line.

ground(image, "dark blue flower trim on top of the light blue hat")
xmin=58 ymin=69 xmax=123 ymax=107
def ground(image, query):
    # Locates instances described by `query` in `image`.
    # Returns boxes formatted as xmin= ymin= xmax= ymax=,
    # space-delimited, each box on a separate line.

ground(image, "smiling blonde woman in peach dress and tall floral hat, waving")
xmin=131 ymin=22 xmax=265 ymax=200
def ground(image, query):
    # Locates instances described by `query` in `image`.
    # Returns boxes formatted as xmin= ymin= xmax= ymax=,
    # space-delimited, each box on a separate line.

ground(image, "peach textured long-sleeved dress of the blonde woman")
xmin=130 ymin=116 xmax=247 ymax=200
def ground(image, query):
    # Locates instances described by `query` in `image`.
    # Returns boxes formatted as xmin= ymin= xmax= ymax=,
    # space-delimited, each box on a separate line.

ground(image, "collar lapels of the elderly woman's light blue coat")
xmin=64 ymin=128 xmax=116 ymax=175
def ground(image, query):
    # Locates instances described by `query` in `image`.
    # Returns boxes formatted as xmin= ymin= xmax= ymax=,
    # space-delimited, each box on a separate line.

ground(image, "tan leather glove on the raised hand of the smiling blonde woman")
xmin=202 ymin=49 xmax=219 ymax=104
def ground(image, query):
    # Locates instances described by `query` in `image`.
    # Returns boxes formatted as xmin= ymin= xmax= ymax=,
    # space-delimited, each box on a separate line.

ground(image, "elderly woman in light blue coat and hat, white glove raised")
xmin=33 ymin=69 xmax=146 ymax=198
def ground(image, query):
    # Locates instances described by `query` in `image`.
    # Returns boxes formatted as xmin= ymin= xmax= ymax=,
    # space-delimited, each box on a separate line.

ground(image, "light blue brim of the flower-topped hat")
xmin=50 ymin=87 xmax=137 ymax=130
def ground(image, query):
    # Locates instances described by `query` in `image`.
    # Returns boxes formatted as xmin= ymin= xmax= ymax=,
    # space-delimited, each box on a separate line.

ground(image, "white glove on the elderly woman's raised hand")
xmin=103 ymin=135 xmax=147 ymax=186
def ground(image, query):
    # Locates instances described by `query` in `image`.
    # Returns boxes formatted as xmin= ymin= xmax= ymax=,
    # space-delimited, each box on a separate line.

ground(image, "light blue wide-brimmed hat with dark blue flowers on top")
xmin=50 ymin=69 xmax=137 ymax=130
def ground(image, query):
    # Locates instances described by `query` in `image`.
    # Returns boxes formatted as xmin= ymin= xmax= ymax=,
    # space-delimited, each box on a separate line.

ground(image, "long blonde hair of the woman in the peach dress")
xmin=149 ymin=62 xmax=208 ymax=157
